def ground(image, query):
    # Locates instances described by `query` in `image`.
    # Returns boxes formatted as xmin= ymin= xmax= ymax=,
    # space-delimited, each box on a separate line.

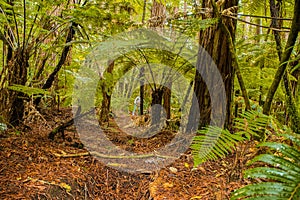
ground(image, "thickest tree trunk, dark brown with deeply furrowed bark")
xmin=194 ymin=0 xmax=238 ymax=127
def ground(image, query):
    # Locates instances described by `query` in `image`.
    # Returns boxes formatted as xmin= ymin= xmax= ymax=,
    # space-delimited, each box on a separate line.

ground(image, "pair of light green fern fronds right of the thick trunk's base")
xmin=191 ymin=111 xmax=276 ymax=167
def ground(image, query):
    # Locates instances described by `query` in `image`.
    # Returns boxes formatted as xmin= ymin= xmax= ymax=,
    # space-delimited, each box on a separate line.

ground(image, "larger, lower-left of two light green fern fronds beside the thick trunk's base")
xmin=191 ymin=126 xmax=245 ymax=166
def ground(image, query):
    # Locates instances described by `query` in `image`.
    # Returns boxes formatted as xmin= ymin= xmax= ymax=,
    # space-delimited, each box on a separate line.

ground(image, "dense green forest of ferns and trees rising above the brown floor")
xmin=0 ymin=0 xmax=300 ymax=200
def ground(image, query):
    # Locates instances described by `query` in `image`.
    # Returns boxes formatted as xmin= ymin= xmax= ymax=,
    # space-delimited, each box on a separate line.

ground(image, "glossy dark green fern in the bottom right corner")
xmin=231 ymin=134 xmax=300 ymax=200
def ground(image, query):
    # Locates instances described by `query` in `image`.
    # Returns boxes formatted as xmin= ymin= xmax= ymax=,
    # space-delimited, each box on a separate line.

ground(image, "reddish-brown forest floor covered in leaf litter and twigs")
xmin=0 ymin=109 xmax=256 ymax=200
